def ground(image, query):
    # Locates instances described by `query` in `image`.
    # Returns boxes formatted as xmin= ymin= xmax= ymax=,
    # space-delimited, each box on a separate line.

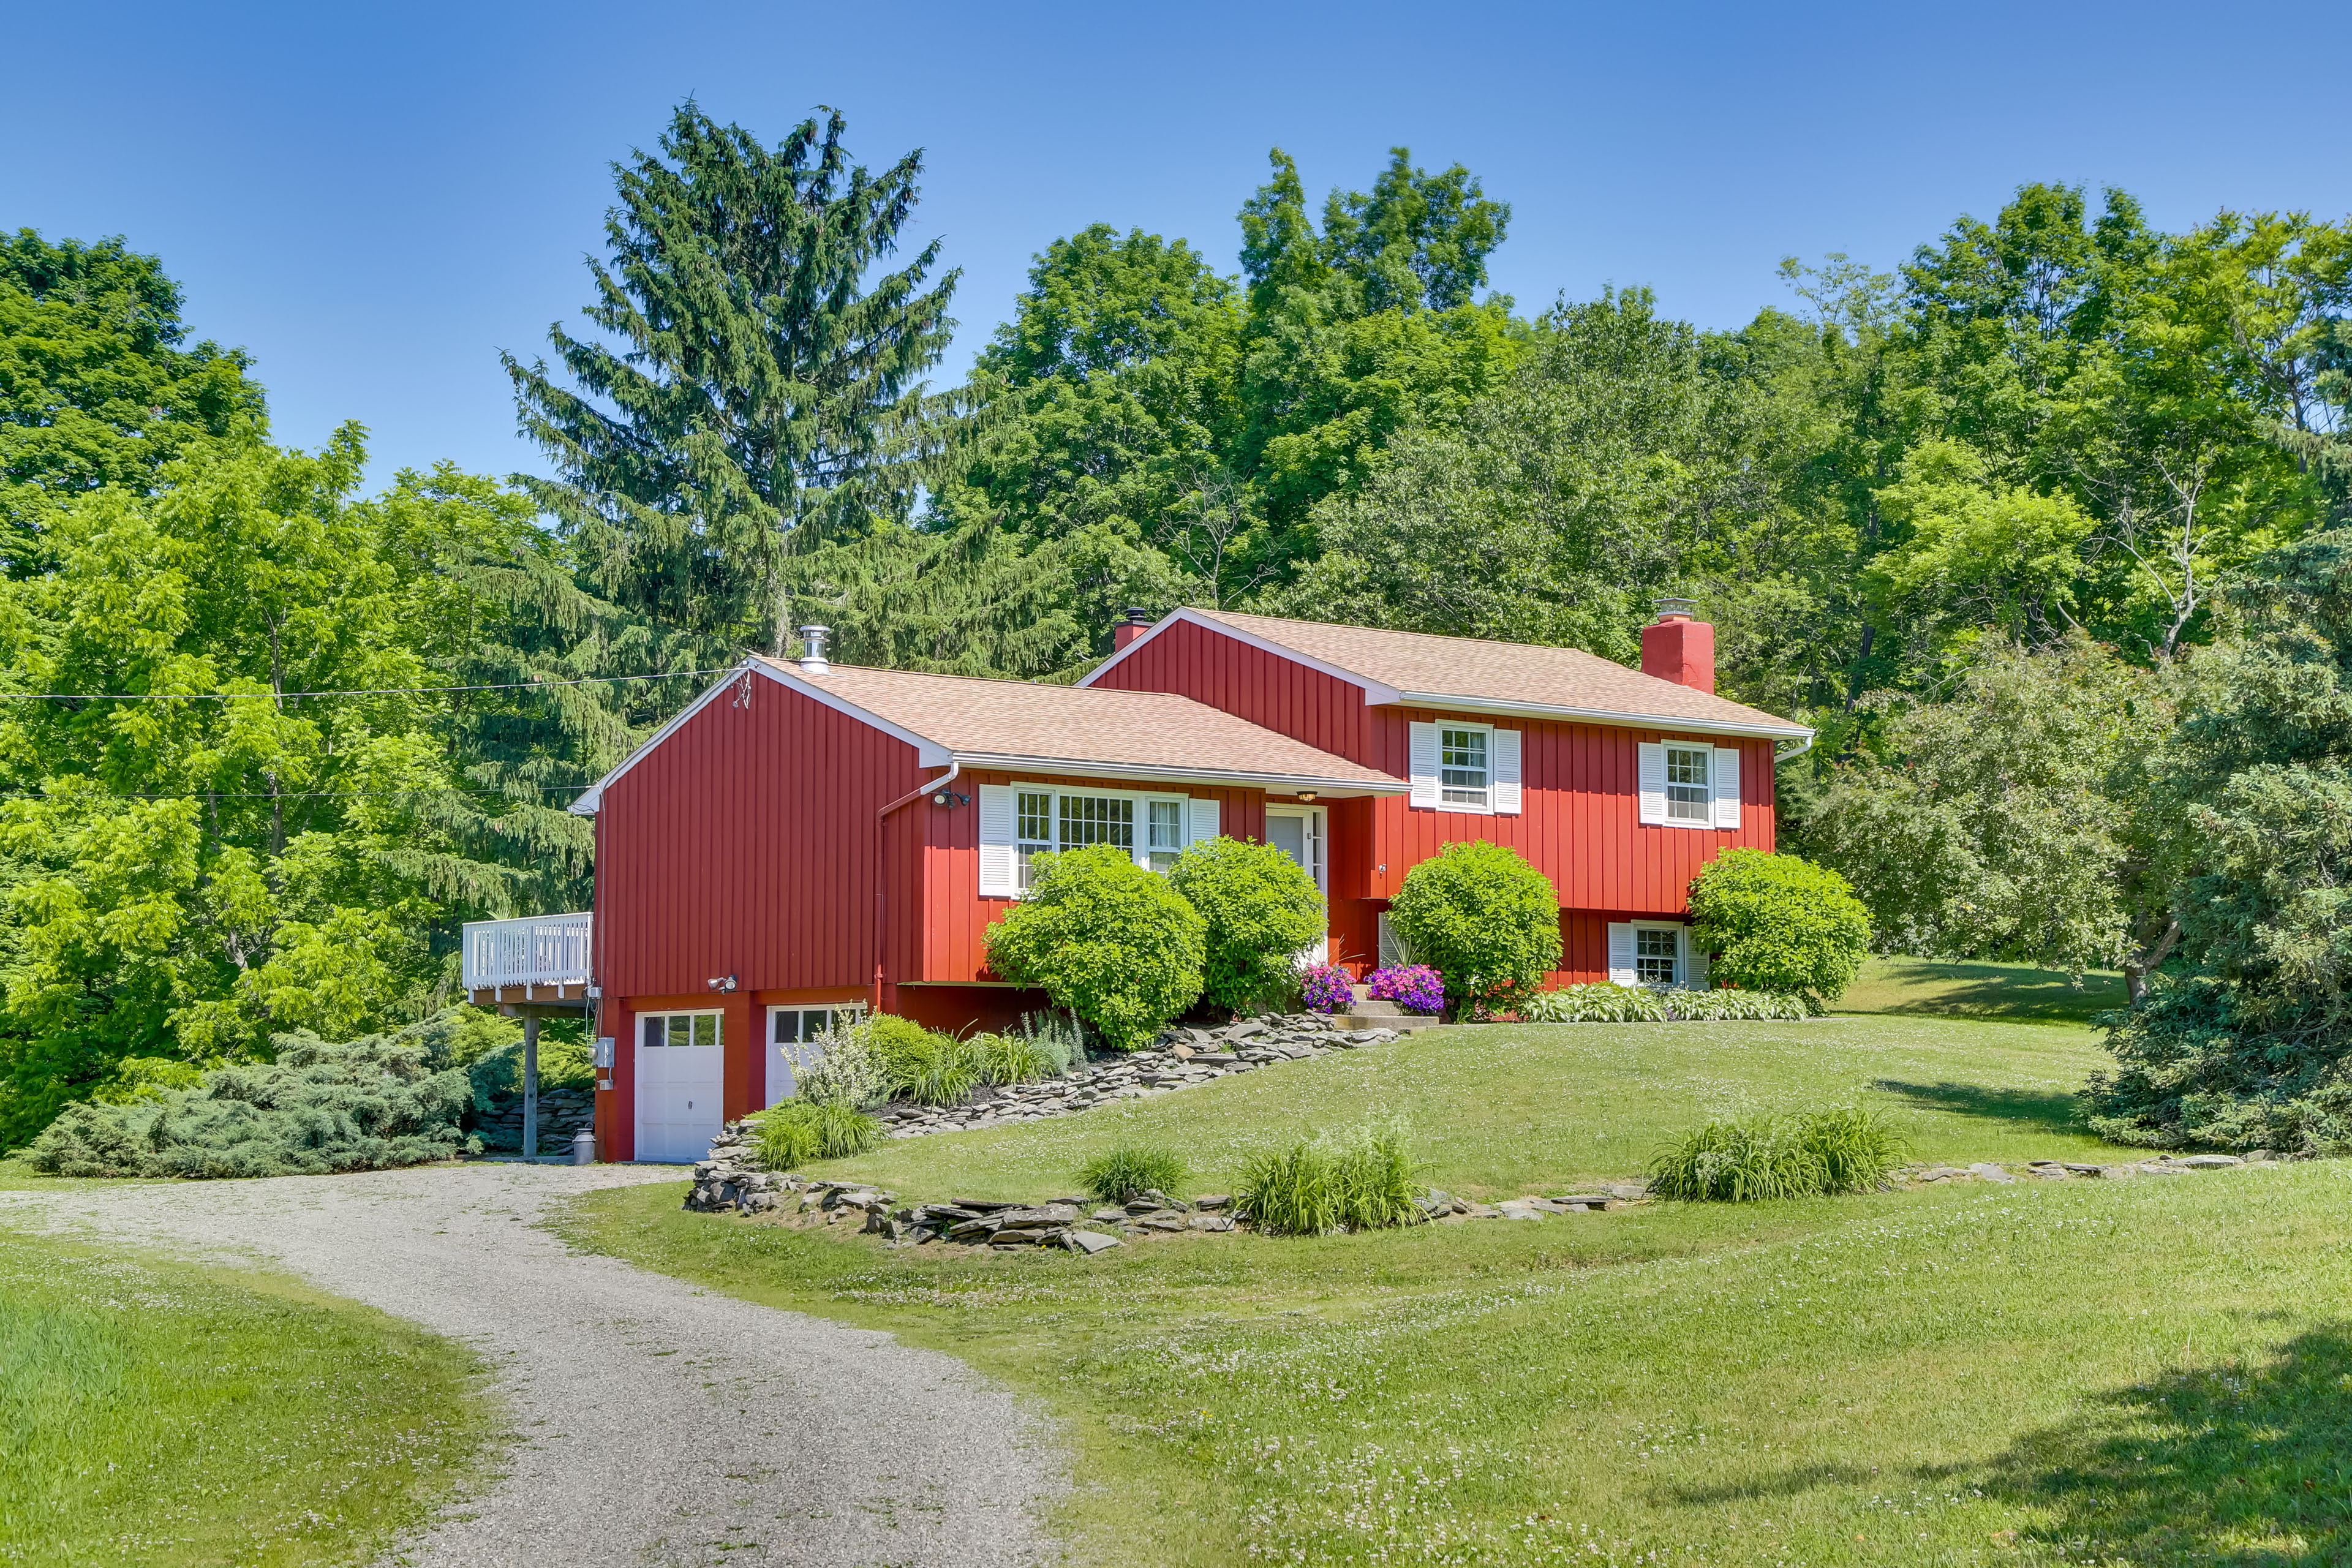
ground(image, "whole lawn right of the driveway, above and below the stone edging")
xmin=567 ymin=982 xmax=2352 ymax=1568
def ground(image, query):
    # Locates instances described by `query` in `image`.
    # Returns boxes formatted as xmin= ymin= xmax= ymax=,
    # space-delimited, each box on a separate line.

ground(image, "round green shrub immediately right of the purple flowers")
xmin=1388 ymin=839 xmax=1559 ymax=1018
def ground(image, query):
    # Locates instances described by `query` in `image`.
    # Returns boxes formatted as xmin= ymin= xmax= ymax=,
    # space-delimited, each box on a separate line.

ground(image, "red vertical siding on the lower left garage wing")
xmin=595 ymin=679 xmax=1265 ymax=1159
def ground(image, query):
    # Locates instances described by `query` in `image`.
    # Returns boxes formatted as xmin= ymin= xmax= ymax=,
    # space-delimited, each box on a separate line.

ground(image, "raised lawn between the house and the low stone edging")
xmin=816 ymin=1016 xmax=2108 ymax=1199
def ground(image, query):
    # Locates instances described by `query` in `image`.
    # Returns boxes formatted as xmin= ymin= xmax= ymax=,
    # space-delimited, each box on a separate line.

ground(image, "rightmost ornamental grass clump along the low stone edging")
xmin=1649 ymin=1105 xmax=1903 ymax=1204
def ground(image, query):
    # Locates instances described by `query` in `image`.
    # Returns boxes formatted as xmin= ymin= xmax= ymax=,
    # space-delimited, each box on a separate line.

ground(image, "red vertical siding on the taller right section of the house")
xmin=1096 ymin=620 xmax=1773 ymax=980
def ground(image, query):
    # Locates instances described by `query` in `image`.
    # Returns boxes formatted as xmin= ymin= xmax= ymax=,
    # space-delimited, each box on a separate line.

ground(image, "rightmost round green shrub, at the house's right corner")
xmin=1691 ymin=849 xmax=1870 ymax=1013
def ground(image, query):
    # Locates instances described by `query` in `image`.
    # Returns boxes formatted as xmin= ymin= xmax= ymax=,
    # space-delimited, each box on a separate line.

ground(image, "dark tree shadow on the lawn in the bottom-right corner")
xmin=1672 ymin=1326 xmax=2352 ymax=1568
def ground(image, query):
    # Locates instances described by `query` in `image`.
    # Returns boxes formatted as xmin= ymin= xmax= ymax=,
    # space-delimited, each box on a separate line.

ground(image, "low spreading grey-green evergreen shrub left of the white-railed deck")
xmin=26 ymin=1009 xmax=478 ymax=1178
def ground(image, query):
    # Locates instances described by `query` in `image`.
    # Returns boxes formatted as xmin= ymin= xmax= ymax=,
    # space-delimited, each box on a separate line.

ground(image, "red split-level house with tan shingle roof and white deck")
xmin=466 ymin=602 xmax=1811 ymax=1159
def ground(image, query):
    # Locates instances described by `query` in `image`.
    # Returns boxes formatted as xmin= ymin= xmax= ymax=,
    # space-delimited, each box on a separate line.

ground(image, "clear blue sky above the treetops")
xmin=0 ymin=0 xmax=2352 ymax=491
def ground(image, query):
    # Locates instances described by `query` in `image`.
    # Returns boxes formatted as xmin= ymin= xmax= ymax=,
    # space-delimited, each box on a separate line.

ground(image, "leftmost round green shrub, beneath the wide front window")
xmin=988 ymin=844 xmax=1209 ymax=1051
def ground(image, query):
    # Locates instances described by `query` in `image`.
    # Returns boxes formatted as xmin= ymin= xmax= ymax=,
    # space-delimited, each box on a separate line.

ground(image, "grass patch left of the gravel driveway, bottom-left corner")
xmin=0 ymin=1227 xmax=489 ymax=1568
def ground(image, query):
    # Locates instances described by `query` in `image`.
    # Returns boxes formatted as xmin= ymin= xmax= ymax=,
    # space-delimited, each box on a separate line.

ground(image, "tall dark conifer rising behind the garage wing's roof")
xmin=503 ymin=104 xmax=957 ymax=668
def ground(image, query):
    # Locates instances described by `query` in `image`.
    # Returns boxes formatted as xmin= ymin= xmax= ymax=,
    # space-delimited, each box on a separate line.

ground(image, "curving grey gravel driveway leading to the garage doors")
xmin=0 ymin=1164 xmax=1066 ymax=1568
